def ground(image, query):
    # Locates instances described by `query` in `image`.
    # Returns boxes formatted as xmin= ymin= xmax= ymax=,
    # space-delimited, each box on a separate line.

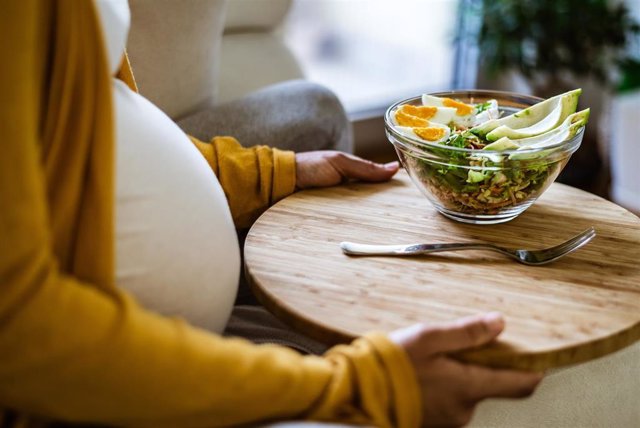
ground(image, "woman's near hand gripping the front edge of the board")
xmin=390 ymin=313 xmax=542 ymax=427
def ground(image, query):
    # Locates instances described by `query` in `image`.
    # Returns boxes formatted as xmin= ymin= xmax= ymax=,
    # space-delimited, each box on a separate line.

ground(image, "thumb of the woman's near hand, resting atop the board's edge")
xmin=410 ymin=312 xmax=504 ymax=358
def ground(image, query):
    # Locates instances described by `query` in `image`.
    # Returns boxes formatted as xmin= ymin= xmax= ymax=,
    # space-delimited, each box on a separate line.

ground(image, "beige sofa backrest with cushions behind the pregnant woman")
xmin=127 ymin=0 xmax=303 ymax=120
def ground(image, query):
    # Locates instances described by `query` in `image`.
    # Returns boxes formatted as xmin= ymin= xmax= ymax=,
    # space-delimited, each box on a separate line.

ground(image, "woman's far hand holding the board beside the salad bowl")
xmin=296 ymin=150 xmax=399 ymax=189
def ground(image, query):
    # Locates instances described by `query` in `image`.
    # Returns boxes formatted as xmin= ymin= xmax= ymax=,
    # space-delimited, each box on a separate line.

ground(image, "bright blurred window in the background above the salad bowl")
xmin=284 ymin=0 xmax=458 ymax=118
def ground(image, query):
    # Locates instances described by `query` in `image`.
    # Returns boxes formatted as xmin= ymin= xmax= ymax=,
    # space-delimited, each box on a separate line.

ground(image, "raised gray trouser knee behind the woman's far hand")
xmin=178 ymin=80 xmax=353 ymax=152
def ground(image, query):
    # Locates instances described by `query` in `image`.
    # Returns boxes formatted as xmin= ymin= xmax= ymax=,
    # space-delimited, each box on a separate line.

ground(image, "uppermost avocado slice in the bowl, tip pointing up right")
xmin=471 ymin=89 xmax=582 ymax=141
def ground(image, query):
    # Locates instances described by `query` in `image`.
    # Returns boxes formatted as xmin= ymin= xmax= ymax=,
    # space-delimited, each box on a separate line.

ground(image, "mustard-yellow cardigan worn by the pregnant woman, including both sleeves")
xmin=0 ymin=0 xmax=421 ymax=427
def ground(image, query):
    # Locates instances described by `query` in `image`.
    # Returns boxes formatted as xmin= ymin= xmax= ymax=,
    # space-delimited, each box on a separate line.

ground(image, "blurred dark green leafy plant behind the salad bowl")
xmin=479 ymin=0 xmax=640 ymax=84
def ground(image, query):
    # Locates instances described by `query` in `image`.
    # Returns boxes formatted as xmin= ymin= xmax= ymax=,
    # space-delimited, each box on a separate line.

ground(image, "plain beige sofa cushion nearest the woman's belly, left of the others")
xmin=127 ymin=0 xmax=226 ymax=119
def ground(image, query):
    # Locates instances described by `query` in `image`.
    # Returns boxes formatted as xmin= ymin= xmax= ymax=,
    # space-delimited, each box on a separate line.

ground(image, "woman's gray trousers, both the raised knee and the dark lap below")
xmin=178 ymin=80 xmax=353 ymax=354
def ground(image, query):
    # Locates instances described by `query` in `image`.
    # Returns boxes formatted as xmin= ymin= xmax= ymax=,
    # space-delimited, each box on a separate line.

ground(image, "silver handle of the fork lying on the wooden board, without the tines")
xmin=340 ymin=242 xmax=497 ymax=256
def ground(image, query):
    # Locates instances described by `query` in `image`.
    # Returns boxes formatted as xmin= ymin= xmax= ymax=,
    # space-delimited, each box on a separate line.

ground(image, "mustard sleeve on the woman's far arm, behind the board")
xmin=189 ymin=137 xmax=296 ymax=228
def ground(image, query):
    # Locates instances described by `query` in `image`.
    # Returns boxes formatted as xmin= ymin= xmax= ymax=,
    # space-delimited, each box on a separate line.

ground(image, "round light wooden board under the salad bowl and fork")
xmin=245 ymin=172 xmax=640 ymax=370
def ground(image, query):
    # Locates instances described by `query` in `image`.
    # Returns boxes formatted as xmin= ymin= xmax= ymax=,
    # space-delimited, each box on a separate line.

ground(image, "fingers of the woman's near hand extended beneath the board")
xmin=464 ymin=365 xmax=542 ymax=403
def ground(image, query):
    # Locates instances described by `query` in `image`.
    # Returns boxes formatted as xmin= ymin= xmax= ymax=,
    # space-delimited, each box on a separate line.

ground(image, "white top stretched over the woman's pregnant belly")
xmin=96 ymin=0 xmax=240 ymax=332
